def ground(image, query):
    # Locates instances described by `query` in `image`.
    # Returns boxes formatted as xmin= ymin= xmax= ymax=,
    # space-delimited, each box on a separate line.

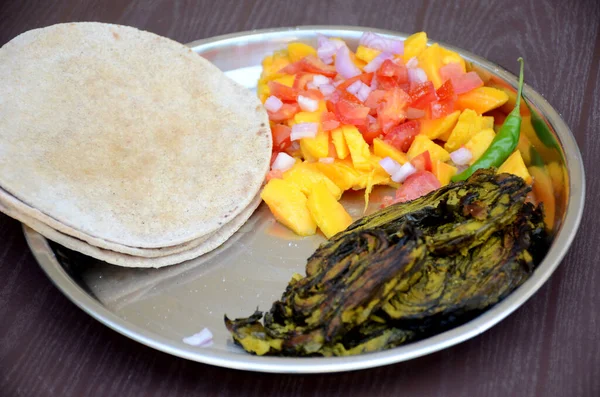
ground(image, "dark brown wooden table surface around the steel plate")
xmin=0 ymin=0 xmax=600 ymax=397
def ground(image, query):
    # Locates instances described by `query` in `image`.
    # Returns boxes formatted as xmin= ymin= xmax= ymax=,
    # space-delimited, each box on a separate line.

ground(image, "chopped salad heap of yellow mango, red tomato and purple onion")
xmin=258 ymin=32 xmax=532 ymax=238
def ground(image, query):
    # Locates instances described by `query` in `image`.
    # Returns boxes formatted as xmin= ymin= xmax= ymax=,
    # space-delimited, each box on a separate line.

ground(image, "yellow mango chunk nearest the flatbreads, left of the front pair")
xmin=260 ymin=178 xmax=317 ymax=236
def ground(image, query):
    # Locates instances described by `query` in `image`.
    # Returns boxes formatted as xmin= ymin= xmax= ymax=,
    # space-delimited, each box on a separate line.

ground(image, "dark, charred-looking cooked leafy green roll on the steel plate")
xmin=225 ymin=170 xmax=548 ymax=356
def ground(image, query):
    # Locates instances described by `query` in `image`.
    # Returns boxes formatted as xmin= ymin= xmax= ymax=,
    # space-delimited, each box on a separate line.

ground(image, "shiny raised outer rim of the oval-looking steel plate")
xmin=23 ymin=25 xmax=586 ymax=373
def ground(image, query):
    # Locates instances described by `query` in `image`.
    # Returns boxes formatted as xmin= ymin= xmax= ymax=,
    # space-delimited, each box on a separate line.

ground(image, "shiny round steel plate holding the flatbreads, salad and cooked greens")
xmin=24 ymin=26 xmax=585 ymax=373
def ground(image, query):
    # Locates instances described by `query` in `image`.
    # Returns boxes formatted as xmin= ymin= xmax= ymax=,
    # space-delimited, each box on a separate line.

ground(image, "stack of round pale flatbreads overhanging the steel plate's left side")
xmin=0 ymin=23 xmax=271 ymax=267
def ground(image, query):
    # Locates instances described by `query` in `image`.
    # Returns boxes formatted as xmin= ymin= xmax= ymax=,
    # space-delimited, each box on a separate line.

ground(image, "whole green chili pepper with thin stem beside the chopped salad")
xmin=452 ymin=58 xmax=523 ymax=182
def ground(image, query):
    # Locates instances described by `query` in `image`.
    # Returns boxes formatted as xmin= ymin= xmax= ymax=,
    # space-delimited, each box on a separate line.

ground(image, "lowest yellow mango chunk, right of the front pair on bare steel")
xmin=306 ymin=182 xmax=352 ymax=238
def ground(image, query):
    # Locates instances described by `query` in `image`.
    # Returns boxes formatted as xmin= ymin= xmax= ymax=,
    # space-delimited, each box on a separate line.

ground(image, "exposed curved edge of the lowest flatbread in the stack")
xmin=8 ymin=195 xmax=261 ymax=268
